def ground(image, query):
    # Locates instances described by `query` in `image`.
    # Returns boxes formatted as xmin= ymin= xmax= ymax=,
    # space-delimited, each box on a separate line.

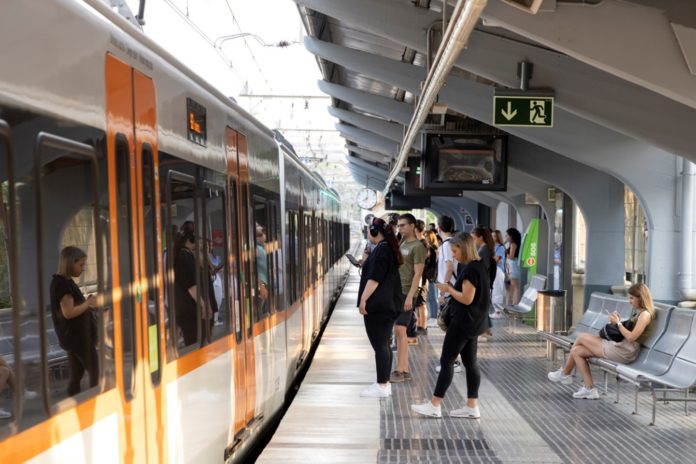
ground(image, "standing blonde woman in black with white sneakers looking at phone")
xmin=411 ymin=233 xmax=491 ymax=419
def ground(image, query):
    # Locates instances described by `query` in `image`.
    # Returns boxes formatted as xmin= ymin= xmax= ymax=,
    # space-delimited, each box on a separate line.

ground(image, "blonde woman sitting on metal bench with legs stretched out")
xmin=548 ymin=284 xmax=655 ymax=400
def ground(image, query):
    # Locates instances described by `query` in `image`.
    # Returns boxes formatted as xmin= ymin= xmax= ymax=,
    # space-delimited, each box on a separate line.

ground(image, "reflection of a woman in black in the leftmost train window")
xmin=50 ymin=246 xmax=99 ymax=396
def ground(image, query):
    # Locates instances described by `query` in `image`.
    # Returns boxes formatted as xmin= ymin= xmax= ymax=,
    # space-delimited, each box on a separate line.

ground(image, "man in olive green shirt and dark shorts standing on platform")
xmin=389 ymin=213 xmax=426 ymax=382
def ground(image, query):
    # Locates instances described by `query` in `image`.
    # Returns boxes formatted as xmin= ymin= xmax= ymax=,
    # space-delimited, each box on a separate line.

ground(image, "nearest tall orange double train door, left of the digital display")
xmin=106 ymin=55 xmax=166 ymax=463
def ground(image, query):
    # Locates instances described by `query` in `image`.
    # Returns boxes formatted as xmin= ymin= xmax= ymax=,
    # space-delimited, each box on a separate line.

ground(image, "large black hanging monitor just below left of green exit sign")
xmin=421 ymin=134 xmax=507 ymax=191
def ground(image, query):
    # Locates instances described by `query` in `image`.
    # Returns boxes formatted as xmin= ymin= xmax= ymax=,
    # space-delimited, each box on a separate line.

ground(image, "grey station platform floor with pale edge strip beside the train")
xmin=257 ymin=275 xmax=696 ymax=464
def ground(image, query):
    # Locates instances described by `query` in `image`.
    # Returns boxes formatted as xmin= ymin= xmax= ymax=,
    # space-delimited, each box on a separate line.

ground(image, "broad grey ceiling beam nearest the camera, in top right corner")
xmin=482 ymin=0 xmax=696 ymax=108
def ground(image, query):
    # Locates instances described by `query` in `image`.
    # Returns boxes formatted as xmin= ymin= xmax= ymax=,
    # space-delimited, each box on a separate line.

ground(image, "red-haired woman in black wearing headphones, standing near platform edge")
xmin=358 ymin=218 xmax=404 ymax=398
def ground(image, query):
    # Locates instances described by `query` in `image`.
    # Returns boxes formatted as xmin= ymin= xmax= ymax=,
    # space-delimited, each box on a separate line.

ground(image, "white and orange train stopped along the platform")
xmin=0 ymin=0 xmax=349 ymax=464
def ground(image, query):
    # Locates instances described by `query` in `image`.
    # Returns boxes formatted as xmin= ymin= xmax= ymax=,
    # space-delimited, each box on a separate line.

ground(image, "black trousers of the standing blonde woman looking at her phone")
xmin=433 ymin=322 xmax=481 ymax=398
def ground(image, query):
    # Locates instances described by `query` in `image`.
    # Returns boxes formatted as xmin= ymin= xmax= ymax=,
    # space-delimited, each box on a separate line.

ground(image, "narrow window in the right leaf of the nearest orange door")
xmin=142 ymin=145 xmax=162 ymax=385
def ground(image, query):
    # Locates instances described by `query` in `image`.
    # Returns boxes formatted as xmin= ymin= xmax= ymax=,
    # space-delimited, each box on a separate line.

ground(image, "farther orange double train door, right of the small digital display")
xmin=226 ymin=127 xmax=256 ymax=442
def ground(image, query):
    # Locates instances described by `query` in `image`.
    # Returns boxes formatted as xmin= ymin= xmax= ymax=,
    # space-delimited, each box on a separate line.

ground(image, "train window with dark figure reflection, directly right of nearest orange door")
xmin=164 ymin=171 xmax=204 ymax=358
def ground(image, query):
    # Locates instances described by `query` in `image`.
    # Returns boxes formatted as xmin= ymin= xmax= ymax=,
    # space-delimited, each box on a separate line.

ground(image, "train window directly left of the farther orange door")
xmin=203 ymin=182 xmax=230 ymax=340
